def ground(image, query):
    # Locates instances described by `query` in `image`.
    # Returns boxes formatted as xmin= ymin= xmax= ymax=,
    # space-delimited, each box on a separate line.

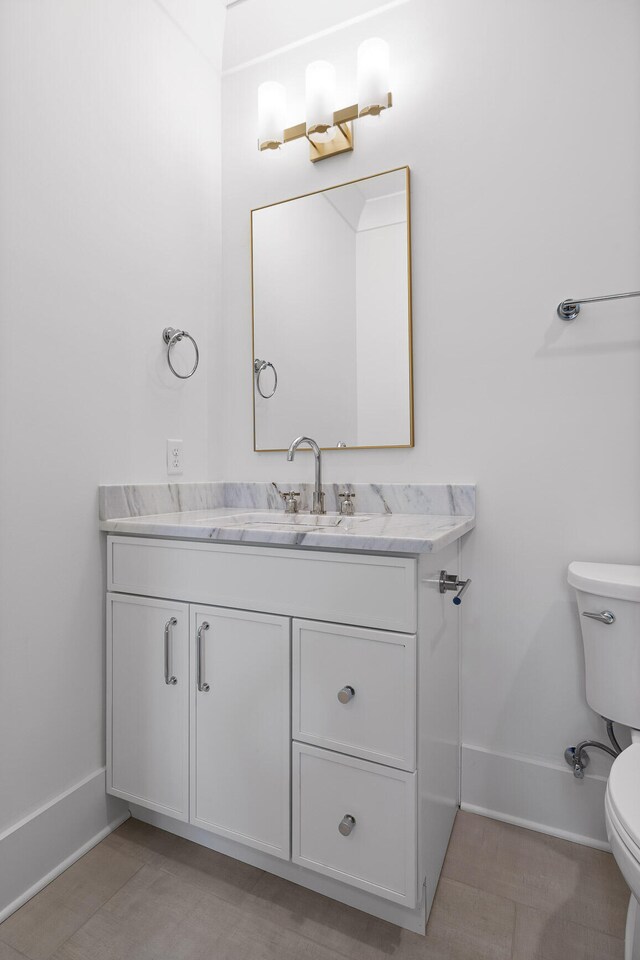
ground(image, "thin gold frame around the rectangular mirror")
xmin=251 ymin=165 xmax=415 ymax=453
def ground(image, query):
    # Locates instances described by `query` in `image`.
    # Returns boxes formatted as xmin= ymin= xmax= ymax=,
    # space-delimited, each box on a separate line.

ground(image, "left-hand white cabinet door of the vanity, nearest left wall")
xmin=107 ymin=594 xmax=189 ymax=820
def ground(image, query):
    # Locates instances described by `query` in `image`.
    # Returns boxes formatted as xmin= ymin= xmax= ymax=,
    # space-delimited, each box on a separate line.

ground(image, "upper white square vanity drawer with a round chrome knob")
xmin=293 ymin=620 xmax=416 ymax=770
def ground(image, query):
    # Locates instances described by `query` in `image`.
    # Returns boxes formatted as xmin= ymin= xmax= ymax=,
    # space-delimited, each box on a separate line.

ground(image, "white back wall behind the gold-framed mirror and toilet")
xmin=215 ymin=0 xmax=640 ymax=840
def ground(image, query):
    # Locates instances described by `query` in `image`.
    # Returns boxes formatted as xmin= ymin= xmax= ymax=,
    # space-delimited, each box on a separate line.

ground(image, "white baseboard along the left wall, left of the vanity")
xmin=0 ymin=767 xmax=129 ymax=923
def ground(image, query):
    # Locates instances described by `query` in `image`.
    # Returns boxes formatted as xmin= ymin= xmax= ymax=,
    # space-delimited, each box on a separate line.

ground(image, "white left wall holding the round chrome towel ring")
xmin=0 ymin=0 xmax=224 ymax=909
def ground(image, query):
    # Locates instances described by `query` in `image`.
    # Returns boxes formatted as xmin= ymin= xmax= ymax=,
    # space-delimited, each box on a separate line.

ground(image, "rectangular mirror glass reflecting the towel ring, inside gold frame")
xmin=251 ymin=167 xmax=413 ymax=451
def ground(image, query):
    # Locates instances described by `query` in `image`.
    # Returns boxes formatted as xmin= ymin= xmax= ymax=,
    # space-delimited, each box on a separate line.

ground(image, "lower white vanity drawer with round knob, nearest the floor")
xmin=292 ymin=743 xmax=417 ymax=908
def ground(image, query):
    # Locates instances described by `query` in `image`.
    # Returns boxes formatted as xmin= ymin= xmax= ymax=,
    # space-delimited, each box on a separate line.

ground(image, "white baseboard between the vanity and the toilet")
xmin=461 ymin=744 xmax=609 ymax=850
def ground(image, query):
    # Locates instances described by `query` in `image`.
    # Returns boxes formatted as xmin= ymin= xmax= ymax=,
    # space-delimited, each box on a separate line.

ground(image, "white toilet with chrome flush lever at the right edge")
xmin=568 ymin=563 xmax=640 ymax=960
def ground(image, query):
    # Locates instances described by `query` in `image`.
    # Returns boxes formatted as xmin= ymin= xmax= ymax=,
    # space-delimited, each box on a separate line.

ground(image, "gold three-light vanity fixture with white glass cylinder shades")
xmin=258 ymin=37 xmax=393 ymax=163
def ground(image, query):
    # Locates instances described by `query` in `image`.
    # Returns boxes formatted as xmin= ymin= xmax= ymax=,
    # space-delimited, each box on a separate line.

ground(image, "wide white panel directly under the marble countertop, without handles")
xmin=107 ymin=536 xmax=417 ymax=633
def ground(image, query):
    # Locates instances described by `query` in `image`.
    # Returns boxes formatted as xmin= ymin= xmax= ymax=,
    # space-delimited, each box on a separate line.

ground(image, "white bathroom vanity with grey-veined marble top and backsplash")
xmin=101 ymin=484 xmax=475 ymax=932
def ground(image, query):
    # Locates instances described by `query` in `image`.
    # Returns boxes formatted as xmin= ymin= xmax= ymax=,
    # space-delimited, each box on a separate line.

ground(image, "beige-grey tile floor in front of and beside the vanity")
xmin=0 ymin=813 xmax=628 ymax=960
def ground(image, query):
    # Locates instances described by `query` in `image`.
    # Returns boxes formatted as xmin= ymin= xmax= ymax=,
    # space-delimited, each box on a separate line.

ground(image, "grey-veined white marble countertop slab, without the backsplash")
xmin=100 ymin=505 xmax=475 ymax=554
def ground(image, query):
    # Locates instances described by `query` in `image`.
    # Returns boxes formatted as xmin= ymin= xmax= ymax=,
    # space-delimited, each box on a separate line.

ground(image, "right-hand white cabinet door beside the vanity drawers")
xmin=191 ymin=606 xmax=290 ymax=859
